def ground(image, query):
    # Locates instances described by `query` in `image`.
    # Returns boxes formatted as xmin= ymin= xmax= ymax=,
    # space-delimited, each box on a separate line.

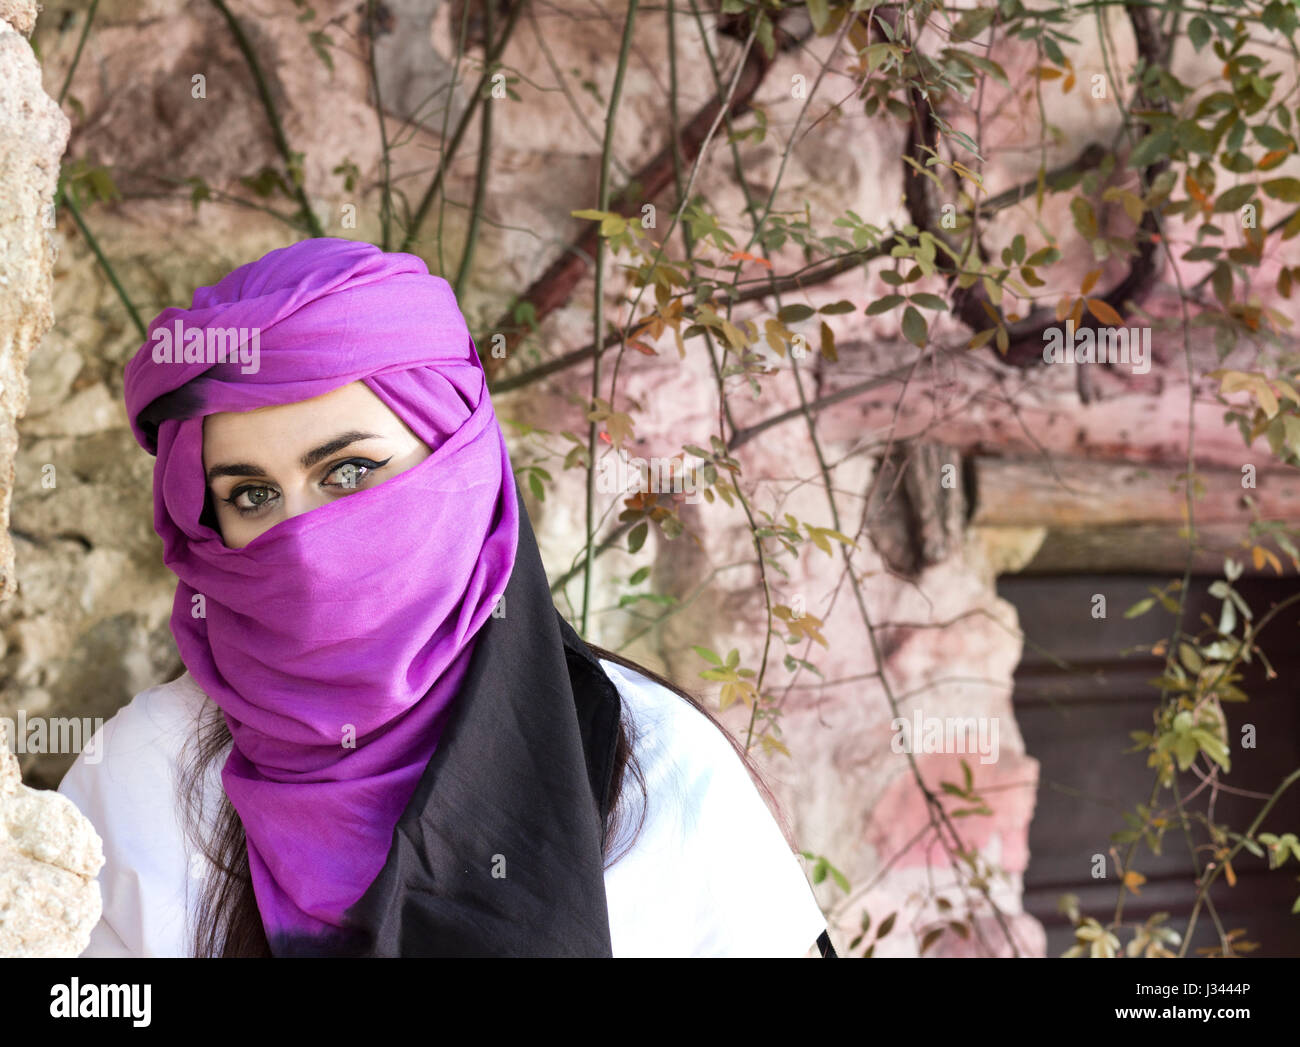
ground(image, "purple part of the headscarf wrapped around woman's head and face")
xmin=126 ymin=238 xmax=520 ymax=936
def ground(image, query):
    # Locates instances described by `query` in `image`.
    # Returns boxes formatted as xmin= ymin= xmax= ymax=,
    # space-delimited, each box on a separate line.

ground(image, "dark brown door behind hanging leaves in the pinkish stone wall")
xmin=997 ymin=575 xmax=1300 ymax=956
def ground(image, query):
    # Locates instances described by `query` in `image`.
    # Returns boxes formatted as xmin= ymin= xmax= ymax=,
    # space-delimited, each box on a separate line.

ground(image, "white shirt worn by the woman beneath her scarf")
xmin=59 ymin=659 xmax=827 ymax=957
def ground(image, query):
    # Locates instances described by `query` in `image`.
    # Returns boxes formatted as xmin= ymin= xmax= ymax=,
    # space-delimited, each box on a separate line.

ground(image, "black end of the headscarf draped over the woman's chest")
xmin=270 ymin=488 xmax=621 ymax=957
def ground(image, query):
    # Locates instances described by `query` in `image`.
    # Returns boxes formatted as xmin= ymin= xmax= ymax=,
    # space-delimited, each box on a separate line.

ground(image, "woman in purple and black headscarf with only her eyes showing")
xmin=60 ymin=238 xmax=833 ymax=956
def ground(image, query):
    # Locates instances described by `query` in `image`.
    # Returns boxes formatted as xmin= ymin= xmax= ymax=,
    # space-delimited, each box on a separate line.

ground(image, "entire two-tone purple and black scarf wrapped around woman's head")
xmin=125 ymin=238 xmax=619 ymax=956
